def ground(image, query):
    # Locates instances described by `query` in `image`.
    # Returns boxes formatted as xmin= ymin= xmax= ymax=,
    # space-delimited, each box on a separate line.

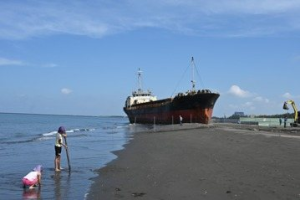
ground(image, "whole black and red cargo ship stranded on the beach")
xmin=124 ymin=58 xmax=220 ymax=124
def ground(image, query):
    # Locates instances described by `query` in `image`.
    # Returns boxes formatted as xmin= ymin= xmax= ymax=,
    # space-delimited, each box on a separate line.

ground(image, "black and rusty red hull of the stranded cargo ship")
xmin=124 ymin=93 xmax=220 ymax=124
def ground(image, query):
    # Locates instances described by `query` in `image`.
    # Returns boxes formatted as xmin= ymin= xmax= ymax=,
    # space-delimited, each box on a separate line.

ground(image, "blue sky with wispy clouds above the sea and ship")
xmin=0 ymin=0 xmax=300 ymax=116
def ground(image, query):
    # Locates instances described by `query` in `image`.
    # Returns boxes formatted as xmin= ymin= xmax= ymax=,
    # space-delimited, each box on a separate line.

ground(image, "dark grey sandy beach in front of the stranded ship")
xmin=87 ymin=124 xmax=300 ymax=200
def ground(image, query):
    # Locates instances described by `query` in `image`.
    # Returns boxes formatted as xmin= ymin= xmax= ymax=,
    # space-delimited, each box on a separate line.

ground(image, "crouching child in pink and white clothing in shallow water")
xmin=22 ymin=165 xmax=42 ymax=189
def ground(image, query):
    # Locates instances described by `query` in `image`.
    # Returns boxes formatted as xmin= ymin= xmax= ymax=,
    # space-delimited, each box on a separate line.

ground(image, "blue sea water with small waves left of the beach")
xmin=0 ymin=113 xmax=134 ymax=199
